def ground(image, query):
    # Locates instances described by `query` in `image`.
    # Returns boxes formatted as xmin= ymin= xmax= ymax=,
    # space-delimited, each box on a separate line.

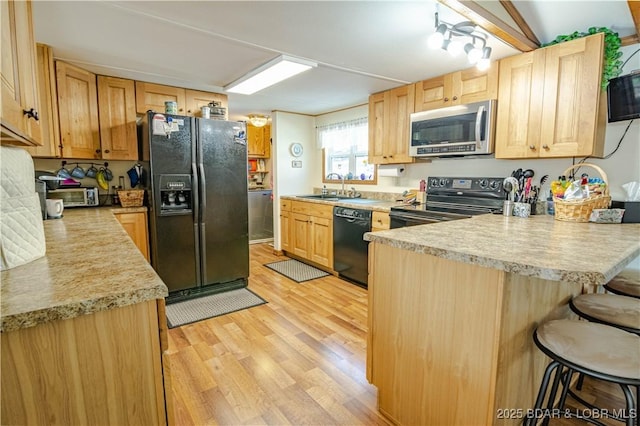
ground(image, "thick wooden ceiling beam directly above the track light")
xmin=438 ymin=0 xmax=540 ymax=52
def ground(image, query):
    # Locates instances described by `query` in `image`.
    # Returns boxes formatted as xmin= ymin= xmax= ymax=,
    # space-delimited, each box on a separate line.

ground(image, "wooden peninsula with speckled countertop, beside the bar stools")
xmin=365 ymin=215 xmax=640 ymax=425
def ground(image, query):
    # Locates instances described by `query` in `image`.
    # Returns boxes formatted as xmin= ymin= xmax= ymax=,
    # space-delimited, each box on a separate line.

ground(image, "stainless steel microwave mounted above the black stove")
xmin=409 ymin=99 xmax=496 ymax=157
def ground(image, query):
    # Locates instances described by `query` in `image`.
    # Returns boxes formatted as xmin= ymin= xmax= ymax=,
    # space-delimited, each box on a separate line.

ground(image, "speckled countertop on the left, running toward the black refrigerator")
xmin=0 ymin=207 xmax=168 ymax=332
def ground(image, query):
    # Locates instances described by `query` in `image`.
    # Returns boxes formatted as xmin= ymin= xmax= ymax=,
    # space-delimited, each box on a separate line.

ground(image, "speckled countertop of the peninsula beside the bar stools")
xmin=364 ymin=214 xmax=640 ymax=285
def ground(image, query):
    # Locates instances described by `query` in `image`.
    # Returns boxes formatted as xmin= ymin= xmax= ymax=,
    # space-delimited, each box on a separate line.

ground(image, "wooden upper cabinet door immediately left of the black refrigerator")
xmin=98 ymin=76 xmax=138 ymax=160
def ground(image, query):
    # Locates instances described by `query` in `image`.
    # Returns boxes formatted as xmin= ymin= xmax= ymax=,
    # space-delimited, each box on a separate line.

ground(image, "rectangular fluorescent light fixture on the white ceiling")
xmin=224 ymin=55 xmax=318 ymax=95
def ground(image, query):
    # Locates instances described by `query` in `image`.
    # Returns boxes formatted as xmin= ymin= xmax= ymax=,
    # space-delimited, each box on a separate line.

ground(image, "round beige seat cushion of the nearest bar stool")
xmin=536 ymin=320 xmax=640 ymax=380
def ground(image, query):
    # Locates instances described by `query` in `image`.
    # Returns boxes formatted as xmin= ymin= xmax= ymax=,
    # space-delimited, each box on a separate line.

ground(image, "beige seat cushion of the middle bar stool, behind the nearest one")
xmin=571 ymin=293 xmax=640 ymax=331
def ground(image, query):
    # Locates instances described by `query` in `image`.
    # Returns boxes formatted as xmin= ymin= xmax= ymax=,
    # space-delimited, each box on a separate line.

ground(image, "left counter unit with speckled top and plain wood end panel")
xmin=0 ymin=207 xmax=170 ymax=425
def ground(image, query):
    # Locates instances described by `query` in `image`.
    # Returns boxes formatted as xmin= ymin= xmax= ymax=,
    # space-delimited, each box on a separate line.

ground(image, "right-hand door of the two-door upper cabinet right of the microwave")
xmin=540 ymin=34 xmax=606 ymax=157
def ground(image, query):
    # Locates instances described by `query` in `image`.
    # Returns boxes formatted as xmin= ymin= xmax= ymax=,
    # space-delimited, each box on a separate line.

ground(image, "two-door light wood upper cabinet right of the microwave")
xmin=496 ymin=33 xmax=607 ymax=158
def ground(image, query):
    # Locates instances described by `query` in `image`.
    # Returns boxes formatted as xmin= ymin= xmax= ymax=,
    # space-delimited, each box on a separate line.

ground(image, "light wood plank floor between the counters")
xmin=168 ymin=244 xmax=623 ymax=426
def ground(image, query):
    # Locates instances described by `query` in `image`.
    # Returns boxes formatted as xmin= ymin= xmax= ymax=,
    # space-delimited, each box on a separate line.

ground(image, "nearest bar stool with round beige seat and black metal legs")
xmin=524 ymin=320 xmax=640 ymax=426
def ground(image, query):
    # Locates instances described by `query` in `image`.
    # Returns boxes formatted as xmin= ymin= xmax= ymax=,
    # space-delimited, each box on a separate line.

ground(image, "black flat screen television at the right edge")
xmin=607 ymin=72 xmax=640 ymax=123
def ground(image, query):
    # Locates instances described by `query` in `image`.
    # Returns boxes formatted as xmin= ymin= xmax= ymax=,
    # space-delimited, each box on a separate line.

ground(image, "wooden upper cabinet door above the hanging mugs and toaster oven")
xmin=56 ymin=61 xmax=102 ymax=159
